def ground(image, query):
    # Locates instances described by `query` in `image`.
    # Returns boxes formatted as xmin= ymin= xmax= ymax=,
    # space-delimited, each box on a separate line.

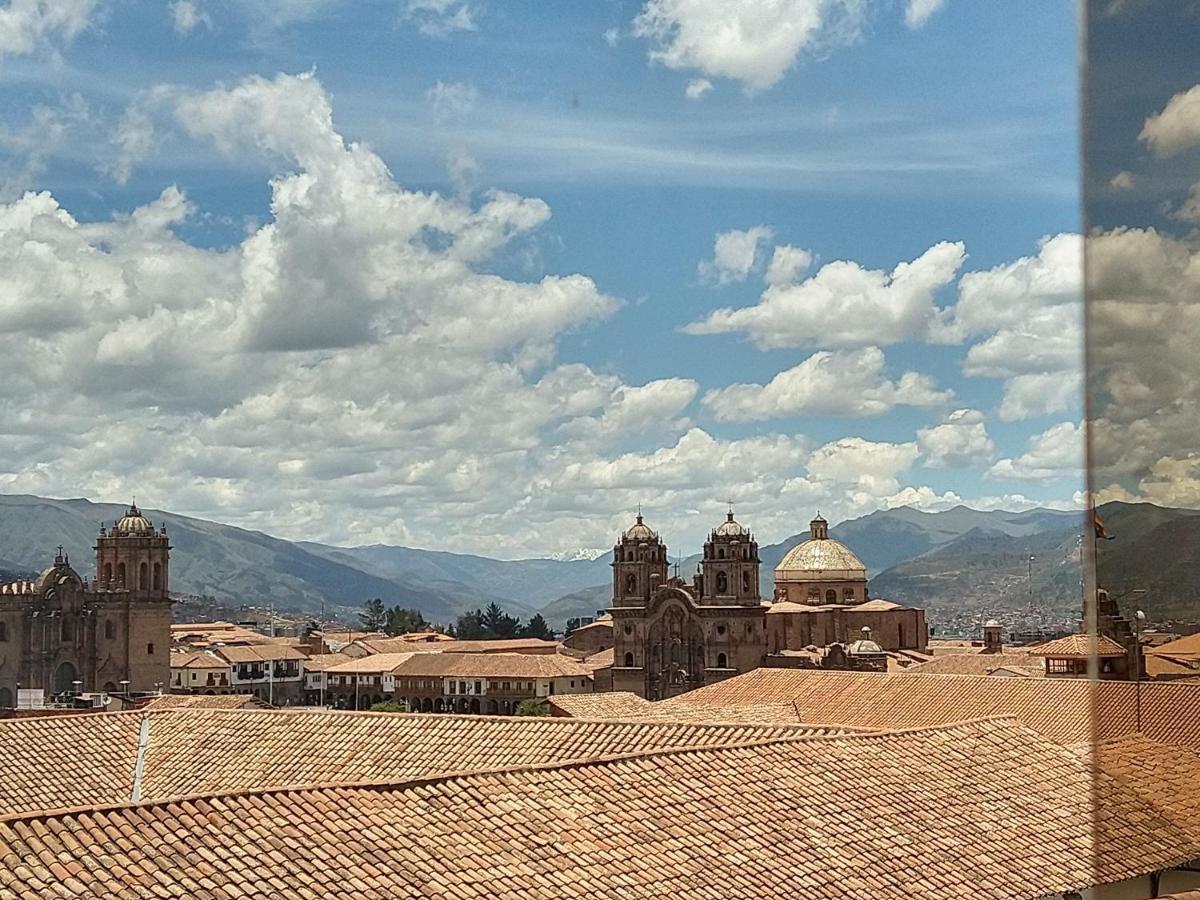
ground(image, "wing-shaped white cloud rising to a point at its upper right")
xmin=684 ymin=241 xmax=966 ymax=349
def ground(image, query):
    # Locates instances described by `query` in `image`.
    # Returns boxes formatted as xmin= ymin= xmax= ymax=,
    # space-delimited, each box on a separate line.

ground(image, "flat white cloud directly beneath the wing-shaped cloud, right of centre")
xmin=704 ymin=347 xmax=953 ymax=421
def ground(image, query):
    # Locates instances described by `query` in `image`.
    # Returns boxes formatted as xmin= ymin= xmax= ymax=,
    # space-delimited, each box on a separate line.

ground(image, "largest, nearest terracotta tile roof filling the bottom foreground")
xmin=0 ymin=714 xmax=1200 ymax=900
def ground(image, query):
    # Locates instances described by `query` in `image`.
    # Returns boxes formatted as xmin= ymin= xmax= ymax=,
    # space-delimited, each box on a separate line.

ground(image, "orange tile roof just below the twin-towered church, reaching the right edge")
xmin=656 ymin=668 xmax=1200 ymax=748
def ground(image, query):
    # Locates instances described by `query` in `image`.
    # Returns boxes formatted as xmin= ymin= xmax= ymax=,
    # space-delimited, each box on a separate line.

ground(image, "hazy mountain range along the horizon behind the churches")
xmin=0 ymin=494 xmax=1200 ymax=628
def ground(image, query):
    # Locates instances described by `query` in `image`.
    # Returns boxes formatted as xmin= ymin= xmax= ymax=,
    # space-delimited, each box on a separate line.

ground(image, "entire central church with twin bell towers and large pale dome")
xmin=612 ymin=510 xmax=929 ymax=700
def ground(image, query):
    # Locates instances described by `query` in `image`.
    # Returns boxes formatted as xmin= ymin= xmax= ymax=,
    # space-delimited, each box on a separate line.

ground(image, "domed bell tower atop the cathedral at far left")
xmin=95 ymin=503 xmax=170 ymax=602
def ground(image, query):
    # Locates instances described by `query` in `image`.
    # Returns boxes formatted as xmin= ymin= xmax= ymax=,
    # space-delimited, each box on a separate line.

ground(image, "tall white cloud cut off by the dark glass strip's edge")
xmin=944 ymin=234 xmax=1084 ymax=420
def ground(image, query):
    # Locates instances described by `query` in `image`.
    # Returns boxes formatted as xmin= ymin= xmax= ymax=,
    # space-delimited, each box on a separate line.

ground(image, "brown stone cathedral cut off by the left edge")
xmin=0 ymin=504 xmax=172 ymax=708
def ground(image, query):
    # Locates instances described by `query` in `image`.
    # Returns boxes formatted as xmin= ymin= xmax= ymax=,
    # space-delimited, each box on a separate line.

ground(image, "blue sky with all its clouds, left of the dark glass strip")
xmin=0 ymin=0 xmax=1081 ymax=556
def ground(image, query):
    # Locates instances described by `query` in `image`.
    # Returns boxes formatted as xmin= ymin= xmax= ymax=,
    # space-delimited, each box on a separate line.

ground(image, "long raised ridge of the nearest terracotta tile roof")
xmin=0 ymin=716 xmax=1022 ymax=823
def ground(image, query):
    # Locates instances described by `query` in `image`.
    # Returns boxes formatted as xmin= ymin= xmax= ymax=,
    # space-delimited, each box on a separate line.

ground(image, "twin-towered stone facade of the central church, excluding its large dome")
xmin=612 ymin=511 xmax=766 ymax=700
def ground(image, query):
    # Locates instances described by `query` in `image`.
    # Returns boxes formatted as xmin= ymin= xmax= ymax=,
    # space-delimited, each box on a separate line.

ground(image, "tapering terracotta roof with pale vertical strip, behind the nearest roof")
xmin=0 ymin=710 xmax=821 ymax=815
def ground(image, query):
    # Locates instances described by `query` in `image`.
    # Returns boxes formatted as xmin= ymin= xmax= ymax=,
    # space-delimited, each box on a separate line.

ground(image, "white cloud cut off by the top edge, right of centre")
xmin=634 ymin=0 xmax=865 ymax=94
